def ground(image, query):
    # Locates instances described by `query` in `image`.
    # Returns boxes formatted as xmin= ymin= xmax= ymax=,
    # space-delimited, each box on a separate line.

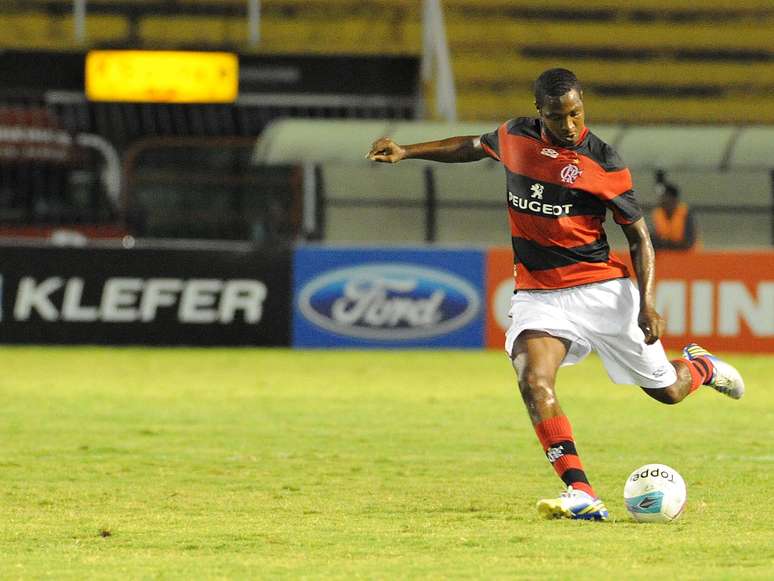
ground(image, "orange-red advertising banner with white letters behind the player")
xmin=486 ymin=248 xmax=774 ymax=353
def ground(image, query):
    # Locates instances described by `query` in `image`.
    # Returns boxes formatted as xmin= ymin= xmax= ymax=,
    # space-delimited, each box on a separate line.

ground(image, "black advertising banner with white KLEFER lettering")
xmin=0 ymin=246 xmax=291 ymax=345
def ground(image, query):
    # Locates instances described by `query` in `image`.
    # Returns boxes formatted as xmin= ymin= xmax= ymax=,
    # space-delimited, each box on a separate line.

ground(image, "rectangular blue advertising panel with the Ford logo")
xmin=293 ymin=246 xmax=485 ymax=348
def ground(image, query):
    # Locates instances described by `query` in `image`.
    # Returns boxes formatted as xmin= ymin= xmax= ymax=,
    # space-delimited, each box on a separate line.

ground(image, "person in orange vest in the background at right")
xmin=650 ymin=183 xmax=697 ymax=250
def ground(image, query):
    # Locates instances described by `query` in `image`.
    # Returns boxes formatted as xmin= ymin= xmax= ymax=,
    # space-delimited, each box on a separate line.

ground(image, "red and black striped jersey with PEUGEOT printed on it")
xmin=481 ymin=117 xmax=642 ymax=290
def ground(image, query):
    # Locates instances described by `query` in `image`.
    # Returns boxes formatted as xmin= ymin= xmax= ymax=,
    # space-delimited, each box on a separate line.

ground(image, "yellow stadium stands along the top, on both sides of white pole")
xmin=0 ymin=0 xmax=774 ymax=123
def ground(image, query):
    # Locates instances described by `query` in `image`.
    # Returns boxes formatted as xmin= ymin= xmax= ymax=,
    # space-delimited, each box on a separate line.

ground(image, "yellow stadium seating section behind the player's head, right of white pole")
xmin=444 ymin=0 xmax=774 ymax=123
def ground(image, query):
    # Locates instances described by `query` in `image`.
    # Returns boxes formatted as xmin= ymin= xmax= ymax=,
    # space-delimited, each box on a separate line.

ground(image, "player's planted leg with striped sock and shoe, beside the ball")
xmin=511 ymin=331 xmax=608 ymax=520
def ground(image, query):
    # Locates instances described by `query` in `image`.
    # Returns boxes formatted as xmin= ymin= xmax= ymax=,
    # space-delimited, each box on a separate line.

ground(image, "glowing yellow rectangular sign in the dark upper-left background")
xmin=86 ymin=50 xmax=239 ymax=103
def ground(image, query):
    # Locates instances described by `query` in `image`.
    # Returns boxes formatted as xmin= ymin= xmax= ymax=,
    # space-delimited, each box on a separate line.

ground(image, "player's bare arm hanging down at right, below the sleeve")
xmin=621 ymin=218 xmax=666 ymax=345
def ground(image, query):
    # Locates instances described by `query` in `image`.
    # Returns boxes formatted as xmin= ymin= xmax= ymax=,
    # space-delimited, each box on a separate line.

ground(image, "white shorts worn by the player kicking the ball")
xmin=505 ymin=278 xmax=677 ymax=389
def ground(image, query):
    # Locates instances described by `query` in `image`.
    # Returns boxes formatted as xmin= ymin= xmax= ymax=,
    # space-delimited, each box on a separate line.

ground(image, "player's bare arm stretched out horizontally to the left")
xmin=366 ymin=135 xmax=488 ymax=163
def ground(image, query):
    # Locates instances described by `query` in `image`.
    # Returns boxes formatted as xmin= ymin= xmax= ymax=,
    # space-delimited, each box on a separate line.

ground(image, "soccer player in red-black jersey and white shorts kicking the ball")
xmin=367 ymin=69 xmax=744 ymax=520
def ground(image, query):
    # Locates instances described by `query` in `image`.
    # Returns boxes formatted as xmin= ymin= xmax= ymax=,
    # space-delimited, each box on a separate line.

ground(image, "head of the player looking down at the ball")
xmin=535 ymin=69 xmax=586 ymax=145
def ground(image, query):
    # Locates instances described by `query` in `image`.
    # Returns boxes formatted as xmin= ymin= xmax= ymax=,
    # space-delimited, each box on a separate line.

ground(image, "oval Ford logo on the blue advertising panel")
xmin=298 ymin=263 xmax=480 ymax=341
